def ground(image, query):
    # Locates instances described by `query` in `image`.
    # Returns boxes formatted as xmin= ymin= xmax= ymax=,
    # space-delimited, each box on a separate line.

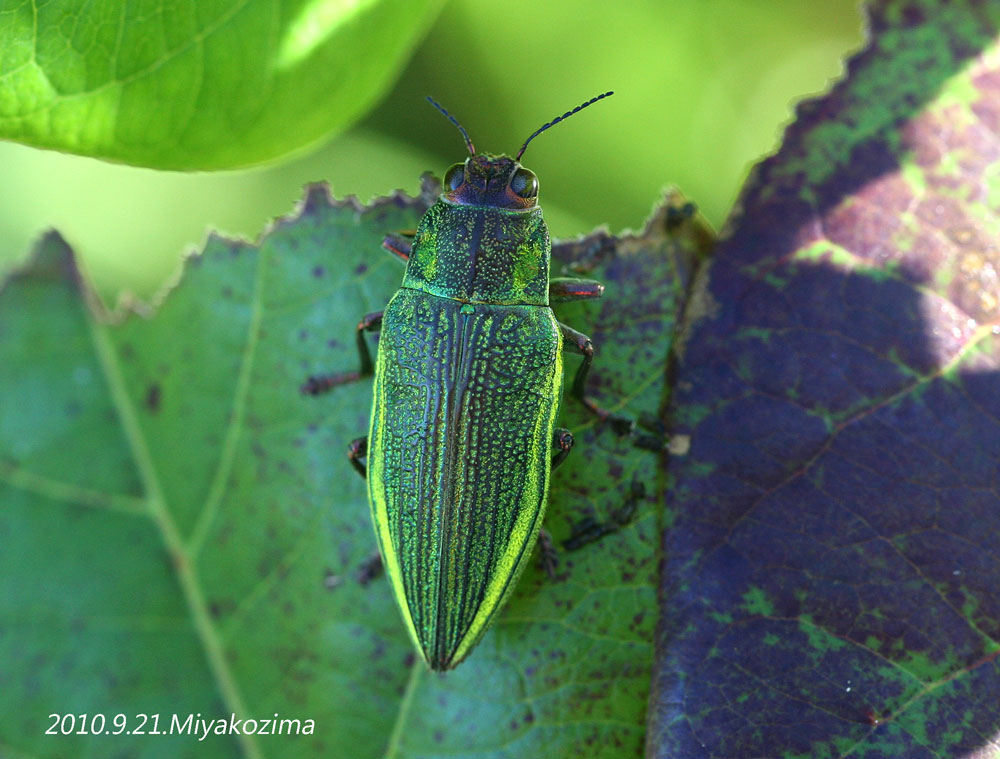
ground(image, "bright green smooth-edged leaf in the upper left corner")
xmin=0 ymin=0 xmax=441 ymax=170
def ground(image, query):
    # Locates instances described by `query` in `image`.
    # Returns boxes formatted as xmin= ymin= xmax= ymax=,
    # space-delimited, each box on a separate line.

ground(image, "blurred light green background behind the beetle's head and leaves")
xmin=0 ymin=0 xmax=863 ymax=301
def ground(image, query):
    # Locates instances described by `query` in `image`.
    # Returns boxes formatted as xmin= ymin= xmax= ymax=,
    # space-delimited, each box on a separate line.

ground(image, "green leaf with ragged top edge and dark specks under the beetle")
xmin=0 ymin=180 xmax=707 ymax=759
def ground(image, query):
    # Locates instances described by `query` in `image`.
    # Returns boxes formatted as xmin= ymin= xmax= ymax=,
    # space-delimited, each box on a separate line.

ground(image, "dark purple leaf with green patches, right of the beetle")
xmin=650 ymin=0 xmax=1000 ymax=759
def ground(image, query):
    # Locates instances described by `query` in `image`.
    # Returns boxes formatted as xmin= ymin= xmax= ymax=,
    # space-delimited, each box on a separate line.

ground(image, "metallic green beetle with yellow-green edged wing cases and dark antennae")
xmin=306 ymin=92 xmax=612 ymax=670
